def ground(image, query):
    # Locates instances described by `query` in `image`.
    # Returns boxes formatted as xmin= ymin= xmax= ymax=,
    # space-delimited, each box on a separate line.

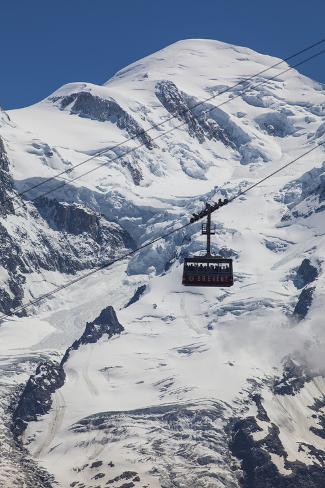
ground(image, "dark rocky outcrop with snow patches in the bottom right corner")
xmin=228 ymin=357 xmax=325 ymax=488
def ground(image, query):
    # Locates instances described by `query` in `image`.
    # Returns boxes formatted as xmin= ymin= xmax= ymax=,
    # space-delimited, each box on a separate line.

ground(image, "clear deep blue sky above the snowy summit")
xmin=0 ymin=0 xmax=325 ymax=109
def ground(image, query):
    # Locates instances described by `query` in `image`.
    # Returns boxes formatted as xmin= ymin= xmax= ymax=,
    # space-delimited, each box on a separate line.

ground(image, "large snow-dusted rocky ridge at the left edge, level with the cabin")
xmin=0 ymin=193 xmax=135 ymax=313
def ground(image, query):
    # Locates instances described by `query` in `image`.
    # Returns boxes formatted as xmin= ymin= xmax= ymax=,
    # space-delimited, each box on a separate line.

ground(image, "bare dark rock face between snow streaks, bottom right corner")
xmin=229 ymin=370 xmax=325 ymax=488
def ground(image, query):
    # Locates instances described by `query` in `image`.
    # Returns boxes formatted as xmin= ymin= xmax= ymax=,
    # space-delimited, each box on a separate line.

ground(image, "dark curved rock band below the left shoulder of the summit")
xmin=51 ymin=91 xmax=153 ymax=149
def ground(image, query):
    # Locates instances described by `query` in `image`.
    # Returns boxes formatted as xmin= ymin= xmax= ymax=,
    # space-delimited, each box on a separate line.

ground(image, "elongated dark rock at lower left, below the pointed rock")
xmin=13 ymin=361 xmax=65 ymax=436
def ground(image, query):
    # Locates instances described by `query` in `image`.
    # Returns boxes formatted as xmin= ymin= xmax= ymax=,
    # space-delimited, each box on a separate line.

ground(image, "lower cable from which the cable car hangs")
xmin=0 ymin=137 xmax=325 ymax=321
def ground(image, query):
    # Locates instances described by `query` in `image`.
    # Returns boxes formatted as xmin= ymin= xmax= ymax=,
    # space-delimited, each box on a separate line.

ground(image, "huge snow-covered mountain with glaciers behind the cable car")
xmin=0 ymin=40 xmax=325 ymax=488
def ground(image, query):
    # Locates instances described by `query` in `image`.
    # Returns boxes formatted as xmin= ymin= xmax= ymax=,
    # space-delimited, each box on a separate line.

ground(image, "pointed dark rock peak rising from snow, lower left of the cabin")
xmin=61 ymin=306 xmax=124 ymax=365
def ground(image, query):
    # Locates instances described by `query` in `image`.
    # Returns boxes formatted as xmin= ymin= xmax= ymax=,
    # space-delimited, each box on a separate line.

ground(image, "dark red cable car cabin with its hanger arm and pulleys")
xmin=182 ymin=201 xmax=234 ymax=287
